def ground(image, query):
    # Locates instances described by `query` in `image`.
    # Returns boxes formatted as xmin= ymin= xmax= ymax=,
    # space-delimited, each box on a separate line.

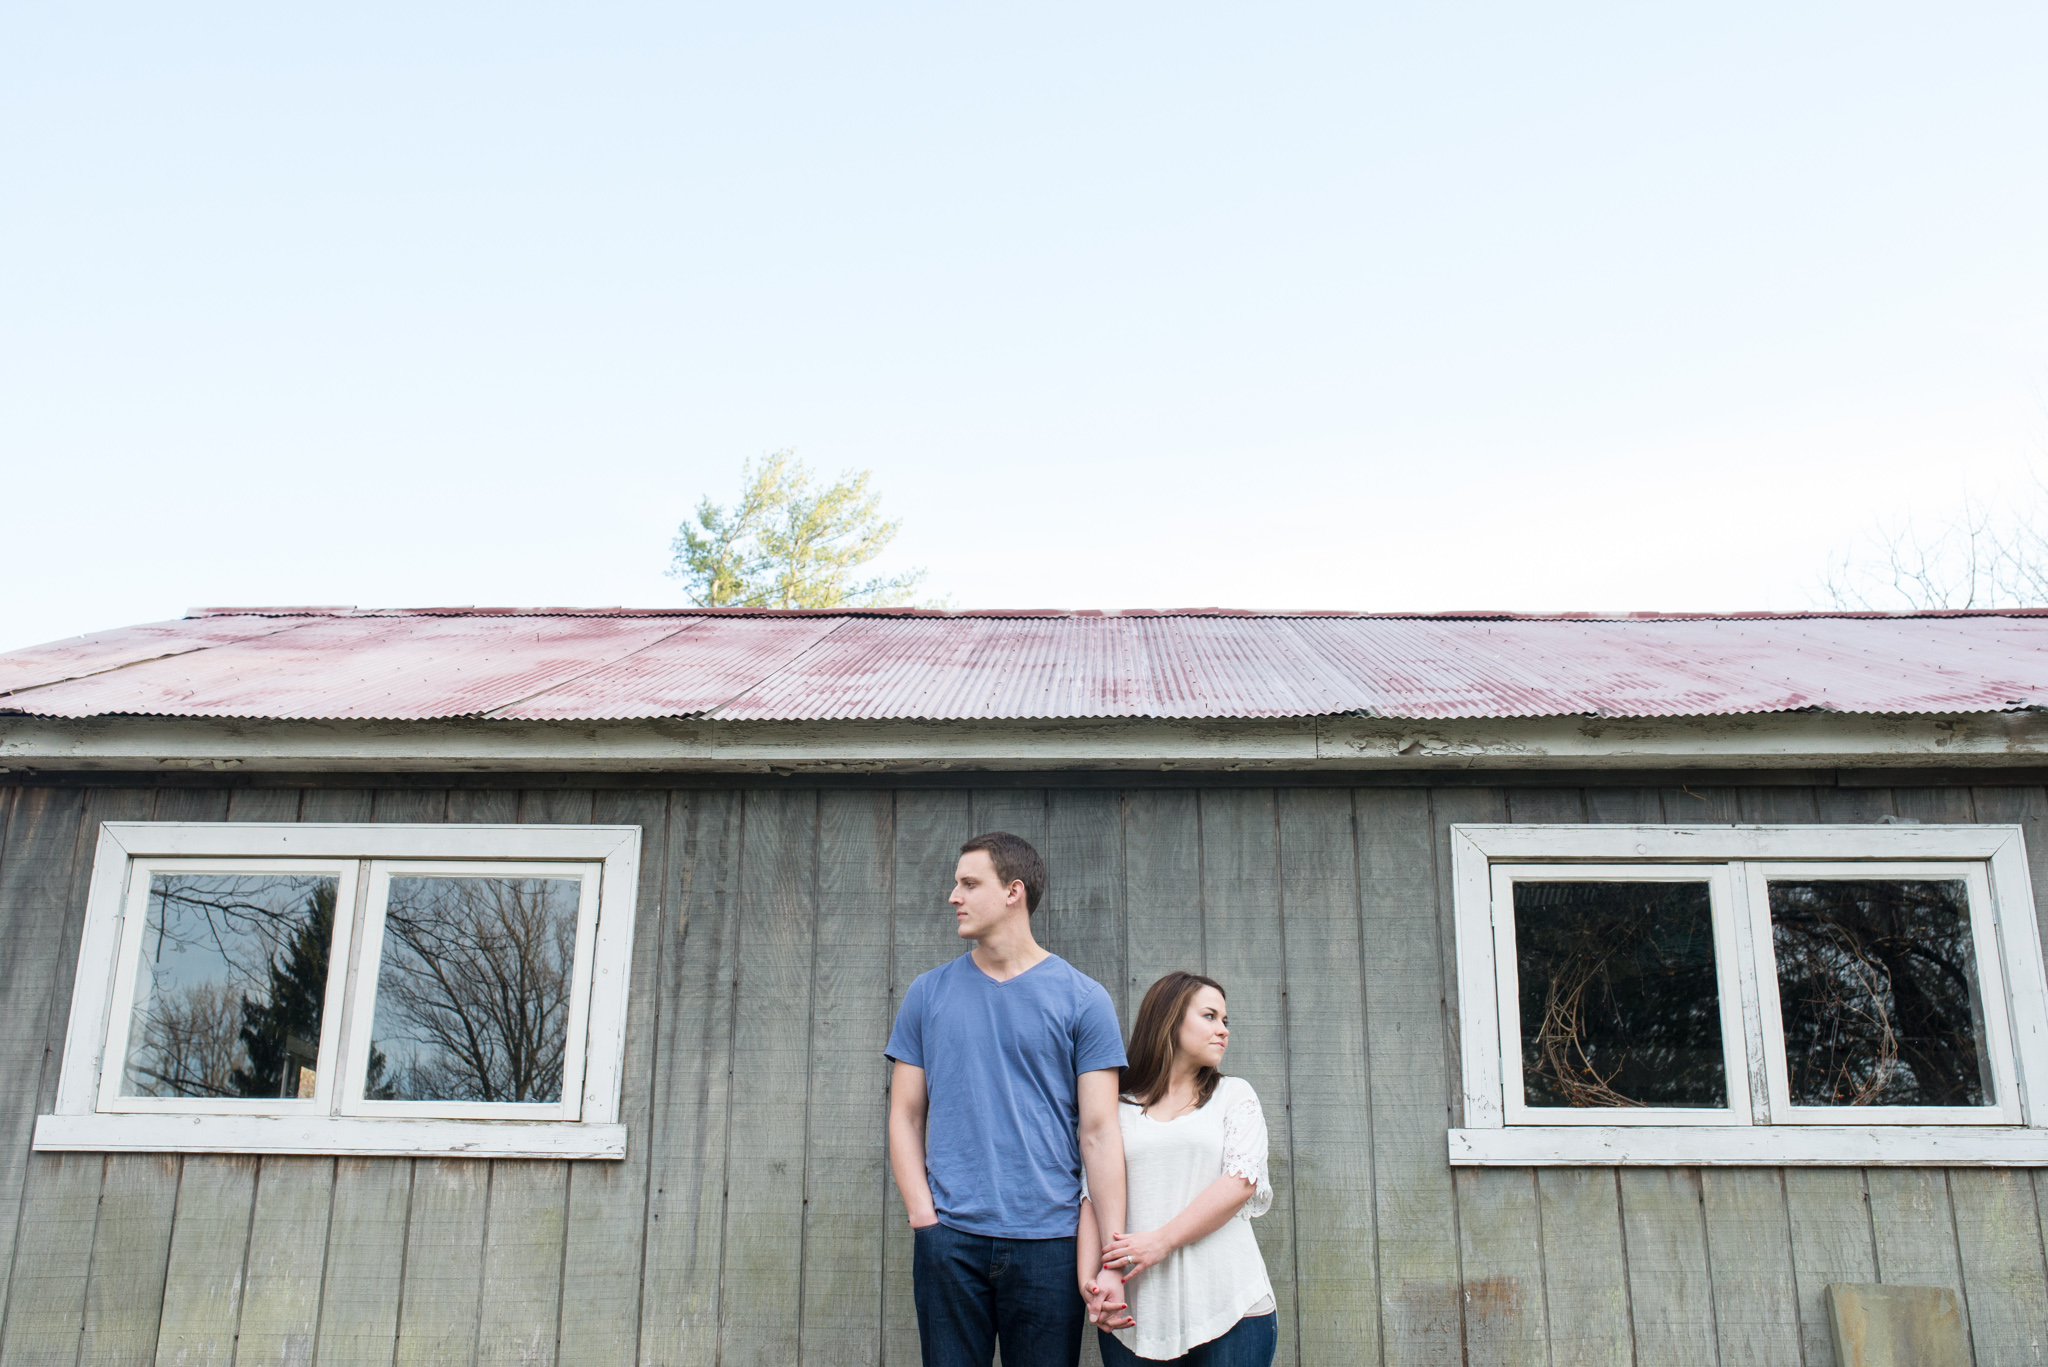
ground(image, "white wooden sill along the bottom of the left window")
xmin=35 ymin=1113 xmax=627 ymax=1158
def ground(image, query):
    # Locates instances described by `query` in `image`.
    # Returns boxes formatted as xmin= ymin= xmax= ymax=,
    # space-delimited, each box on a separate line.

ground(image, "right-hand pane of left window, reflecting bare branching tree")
xmin=362 ymin=875 xmax=584 ymax=1103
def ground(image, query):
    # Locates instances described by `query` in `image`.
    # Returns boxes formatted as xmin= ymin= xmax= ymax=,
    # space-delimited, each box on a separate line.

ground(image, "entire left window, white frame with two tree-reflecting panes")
xmin=48 ymin=822 xmax=639 ymax=1158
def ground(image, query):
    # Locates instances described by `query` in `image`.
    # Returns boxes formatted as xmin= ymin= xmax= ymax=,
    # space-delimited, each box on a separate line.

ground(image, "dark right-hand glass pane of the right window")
xmin=1769 ymin=879 xmax=1993 ymax=1107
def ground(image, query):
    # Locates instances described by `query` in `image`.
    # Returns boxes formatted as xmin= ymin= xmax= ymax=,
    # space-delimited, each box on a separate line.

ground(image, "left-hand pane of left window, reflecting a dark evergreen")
xmin=121 ymin=873 xmax=338 ymax=1096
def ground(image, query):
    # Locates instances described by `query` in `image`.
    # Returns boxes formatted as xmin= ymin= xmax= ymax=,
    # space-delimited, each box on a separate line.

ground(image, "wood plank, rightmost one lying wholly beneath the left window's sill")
xmin=477 ymin=1158 xmax=573 ymax=1367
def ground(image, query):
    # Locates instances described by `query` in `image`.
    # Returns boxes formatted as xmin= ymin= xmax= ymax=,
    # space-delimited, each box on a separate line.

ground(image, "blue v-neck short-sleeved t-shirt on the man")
xmin=885 ymin=953 xmax=1124 ymax=1238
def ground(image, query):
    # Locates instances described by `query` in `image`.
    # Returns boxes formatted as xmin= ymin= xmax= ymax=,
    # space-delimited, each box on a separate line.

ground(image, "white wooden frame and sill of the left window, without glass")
xmin=35 ymin=822 xmax=641 ymax=1158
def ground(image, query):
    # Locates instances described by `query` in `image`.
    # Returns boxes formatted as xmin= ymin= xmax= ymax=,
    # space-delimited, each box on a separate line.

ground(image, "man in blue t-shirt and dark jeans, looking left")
xmin=887 ymin=832 xmax=1124 ymax=1367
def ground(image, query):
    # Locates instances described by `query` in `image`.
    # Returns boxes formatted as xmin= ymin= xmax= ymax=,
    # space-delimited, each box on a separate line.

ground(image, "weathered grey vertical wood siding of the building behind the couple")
xmin=0 ymin=785 xmax=2048 ymax=1367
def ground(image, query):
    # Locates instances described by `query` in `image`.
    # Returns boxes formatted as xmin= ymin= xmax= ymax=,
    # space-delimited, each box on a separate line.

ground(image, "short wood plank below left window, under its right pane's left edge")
xmin=309 ymin=1164 xmax=414 ymax=1367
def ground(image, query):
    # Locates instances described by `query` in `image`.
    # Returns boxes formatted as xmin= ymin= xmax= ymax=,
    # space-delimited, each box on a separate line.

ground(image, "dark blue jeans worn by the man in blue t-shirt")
xmin=911 ymin=1226 xmax=1087 ymax=1367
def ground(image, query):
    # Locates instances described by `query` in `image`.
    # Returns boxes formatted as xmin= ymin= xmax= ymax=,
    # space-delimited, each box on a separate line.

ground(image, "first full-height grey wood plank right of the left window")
xmin=639 ymin=791 xmax=745 ymax=1367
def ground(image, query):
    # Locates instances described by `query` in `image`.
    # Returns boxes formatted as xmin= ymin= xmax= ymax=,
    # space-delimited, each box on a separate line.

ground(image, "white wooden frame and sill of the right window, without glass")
xmin=1450 ymin=824 xmax=2048 ymax=1166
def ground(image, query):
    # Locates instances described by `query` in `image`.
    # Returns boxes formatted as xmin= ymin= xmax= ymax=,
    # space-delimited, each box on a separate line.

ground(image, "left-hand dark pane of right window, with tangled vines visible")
xmin=1516 ymin=881 xmax=1729 ymax=1107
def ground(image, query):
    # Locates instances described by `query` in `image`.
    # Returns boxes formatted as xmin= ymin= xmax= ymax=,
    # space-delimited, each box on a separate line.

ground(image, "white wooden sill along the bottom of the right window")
xmin=1450 ymin=1125 xmax=2048 ymax=1168
